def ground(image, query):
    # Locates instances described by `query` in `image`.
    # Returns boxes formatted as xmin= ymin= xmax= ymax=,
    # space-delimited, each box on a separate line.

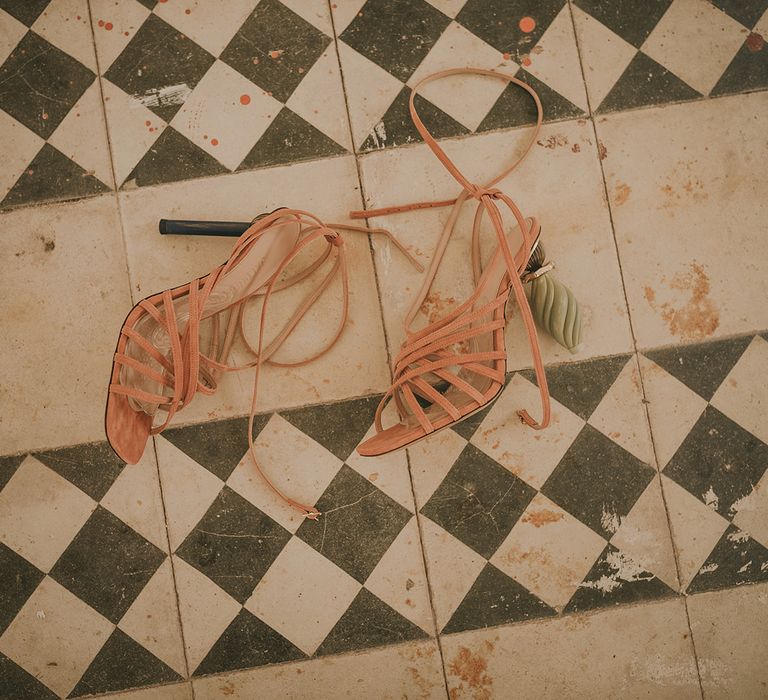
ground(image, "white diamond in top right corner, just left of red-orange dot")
xmin=642 ymin=0 xmax=744 ymax=95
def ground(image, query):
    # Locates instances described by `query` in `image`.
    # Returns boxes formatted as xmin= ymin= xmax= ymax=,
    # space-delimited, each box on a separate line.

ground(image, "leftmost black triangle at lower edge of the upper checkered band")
xmin=0 ymin=143 xmax=109 ymax=207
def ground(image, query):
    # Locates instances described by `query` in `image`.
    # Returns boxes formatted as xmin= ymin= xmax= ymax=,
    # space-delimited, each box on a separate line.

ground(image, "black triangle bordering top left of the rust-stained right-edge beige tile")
xmin=597 ymin=51 xmax=701 ymax=112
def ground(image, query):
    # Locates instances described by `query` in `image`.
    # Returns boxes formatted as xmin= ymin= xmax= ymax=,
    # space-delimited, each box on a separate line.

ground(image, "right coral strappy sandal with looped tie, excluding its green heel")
xmin=351 ymin=68 xmax=550 ymax=456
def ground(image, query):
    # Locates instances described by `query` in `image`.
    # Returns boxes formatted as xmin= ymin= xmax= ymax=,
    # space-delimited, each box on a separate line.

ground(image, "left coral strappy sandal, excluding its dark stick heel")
xmin=105 ymin=208 xmax=423 ymax=519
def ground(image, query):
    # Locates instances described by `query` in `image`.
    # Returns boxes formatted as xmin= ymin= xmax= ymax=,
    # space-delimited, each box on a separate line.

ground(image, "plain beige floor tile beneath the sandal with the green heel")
xmin=360 ymin=120 xmax=632 ymax=369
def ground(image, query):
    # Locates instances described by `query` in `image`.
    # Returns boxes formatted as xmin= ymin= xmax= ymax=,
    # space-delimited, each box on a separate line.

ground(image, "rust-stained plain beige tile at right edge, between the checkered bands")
xmin=597 ymin=93 xmax=768 ymax=348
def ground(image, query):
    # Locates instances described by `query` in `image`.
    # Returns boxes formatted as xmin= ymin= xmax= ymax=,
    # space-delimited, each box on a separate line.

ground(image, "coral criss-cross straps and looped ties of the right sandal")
xmin=350 ymin=68 xmax=550 ymax=432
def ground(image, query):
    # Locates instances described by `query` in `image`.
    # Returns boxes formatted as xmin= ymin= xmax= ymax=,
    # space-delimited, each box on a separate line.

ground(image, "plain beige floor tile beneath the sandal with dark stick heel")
xmin=120 ymin=158 xmax=389 ymax=422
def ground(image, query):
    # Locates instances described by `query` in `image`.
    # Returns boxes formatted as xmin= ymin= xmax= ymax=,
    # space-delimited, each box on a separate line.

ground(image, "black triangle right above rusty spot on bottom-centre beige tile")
xmin=442 ymin=564 xmax=557 ymax=634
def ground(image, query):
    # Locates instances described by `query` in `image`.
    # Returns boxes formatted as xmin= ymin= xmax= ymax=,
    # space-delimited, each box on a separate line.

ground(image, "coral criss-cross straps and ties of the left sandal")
xmin=109 ymin=209 xmax=423 ymax=519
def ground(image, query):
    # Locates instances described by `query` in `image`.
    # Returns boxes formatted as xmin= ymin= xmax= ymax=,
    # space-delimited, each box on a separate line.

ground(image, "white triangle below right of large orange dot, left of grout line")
xmin=526 ymin=5 xmax=587 ymax=112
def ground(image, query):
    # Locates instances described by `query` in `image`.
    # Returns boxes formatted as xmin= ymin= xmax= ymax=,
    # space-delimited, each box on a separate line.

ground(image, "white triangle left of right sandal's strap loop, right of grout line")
xmin=337 ymin=41 xmax=403 ymax=147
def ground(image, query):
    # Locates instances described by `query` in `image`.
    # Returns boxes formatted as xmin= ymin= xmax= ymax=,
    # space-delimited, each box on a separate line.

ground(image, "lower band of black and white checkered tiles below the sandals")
xmin=0 ymin=334 xmax=768 ymax=698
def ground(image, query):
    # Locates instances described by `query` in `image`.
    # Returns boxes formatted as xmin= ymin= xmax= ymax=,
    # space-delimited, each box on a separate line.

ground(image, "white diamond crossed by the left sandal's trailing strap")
xmin=227 ymin=415 xmax=342 ymax=532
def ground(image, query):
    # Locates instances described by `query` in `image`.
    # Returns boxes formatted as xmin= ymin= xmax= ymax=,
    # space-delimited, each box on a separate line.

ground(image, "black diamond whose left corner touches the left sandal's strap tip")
xmin=296 ymin=464 xmax=412 ymax=583
